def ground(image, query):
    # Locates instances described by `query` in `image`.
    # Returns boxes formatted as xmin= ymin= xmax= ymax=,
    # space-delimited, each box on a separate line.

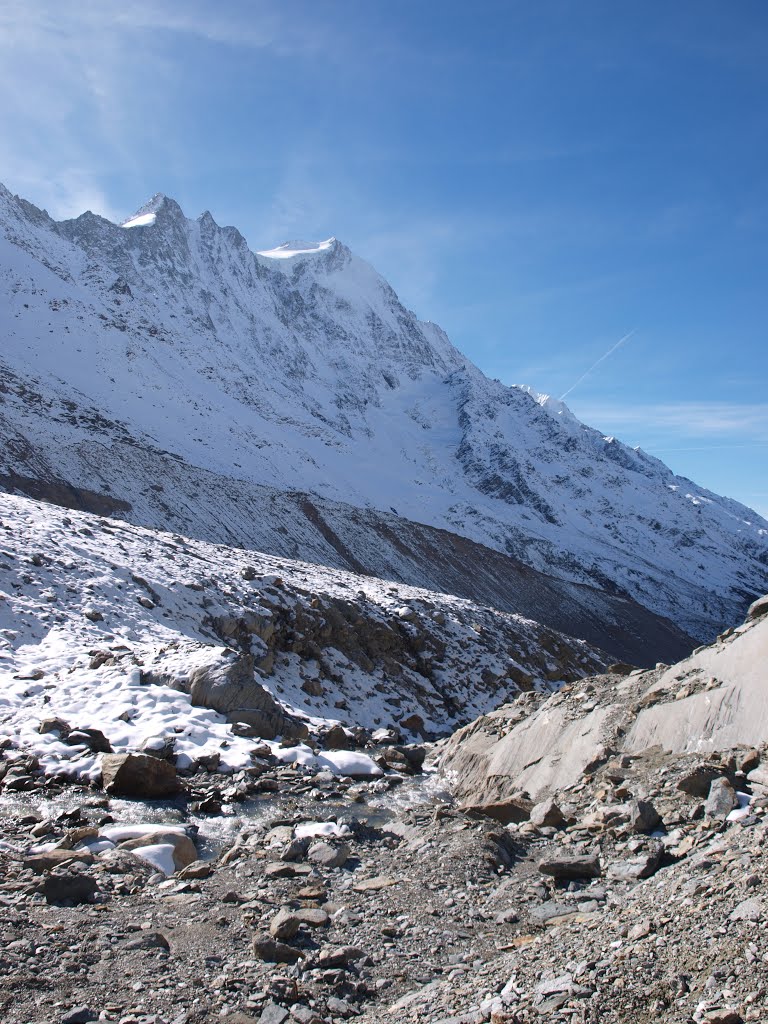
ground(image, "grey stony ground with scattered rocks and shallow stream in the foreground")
xmin=0 ymin=729 xmax=768 ymax=1024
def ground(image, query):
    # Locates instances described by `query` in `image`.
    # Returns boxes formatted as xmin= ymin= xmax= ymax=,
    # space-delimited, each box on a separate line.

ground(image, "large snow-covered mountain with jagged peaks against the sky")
xmin=0 ymin=186 xmax=768 ymax=656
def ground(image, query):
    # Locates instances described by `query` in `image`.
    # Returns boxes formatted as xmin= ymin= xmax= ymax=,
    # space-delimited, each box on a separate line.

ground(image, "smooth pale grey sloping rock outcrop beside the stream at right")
xmin=441 ymin=601 xmax=768 ymax=804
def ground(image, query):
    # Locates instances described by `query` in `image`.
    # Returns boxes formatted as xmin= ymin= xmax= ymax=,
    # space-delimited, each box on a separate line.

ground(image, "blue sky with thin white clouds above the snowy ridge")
xmin=0 ymin=0 xmax=768 ymax=515
